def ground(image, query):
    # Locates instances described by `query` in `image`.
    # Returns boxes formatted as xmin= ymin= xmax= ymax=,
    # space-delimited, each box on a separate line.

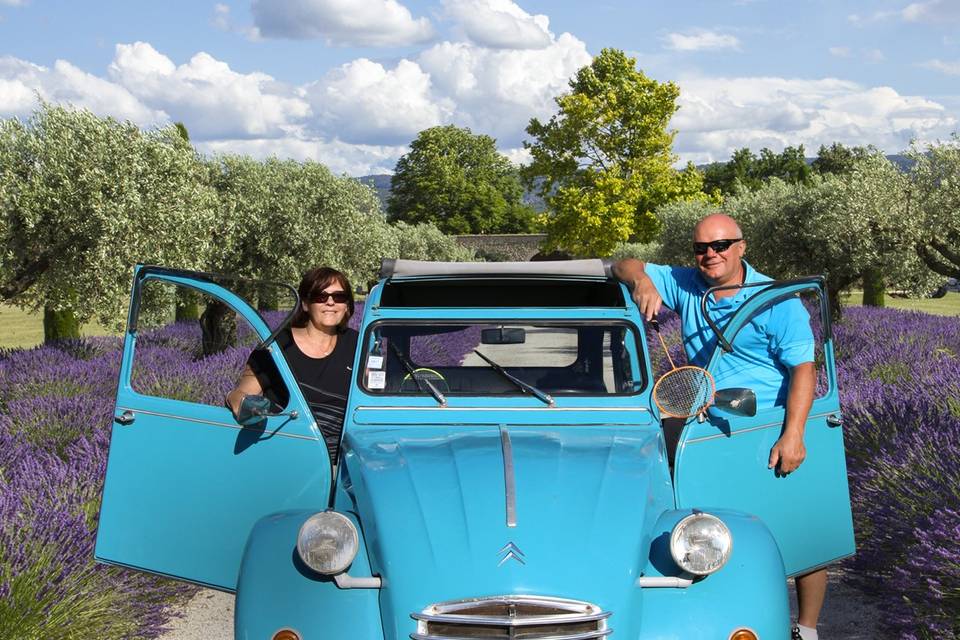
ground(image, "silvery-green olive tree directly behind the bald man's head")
xmin=659 ymin=154 xmax=931 ymax=314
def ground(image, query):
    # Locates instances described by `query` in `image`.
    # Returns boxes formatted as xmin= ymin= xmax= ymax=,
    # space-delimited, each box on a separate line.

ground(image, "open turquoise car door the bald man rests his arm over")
xmin=675 ymin=278 xmax=855 ymax=575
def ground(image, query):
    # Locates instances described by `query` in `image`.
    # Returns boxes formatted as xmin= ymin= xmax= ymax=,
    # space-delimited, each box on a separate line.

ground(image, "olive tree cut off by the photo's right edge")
xmin=909 ymin=134 xmax=960 ymax=279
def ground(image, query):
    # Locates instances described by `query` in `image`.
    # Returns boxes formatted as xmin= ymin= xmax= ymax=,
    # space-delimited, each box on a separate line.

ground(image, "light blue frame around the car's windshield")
xmin=354 ymin=314 xmax=651 ymax=404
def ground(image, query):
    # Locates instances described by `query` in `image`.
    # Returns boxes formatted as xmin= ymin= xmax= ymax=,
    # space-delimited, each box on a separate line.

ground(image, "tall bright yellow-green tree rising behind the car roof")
xmin=521 ymin=49 xmax=704 ymax=256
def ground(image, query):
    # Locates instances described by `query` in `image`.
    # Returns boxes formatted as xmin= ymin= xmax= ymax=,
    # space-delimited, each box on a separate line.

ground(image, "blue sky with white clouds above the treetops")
xmin=0 ymin=0 xmax=960 ymax=175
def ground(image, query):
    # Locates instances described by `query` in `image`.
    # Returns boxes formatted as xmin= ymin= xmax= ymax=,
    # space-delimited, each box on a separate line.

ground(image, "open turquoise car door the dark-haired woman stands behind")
xmin=95 ymin=266 xmax=331 ymax=591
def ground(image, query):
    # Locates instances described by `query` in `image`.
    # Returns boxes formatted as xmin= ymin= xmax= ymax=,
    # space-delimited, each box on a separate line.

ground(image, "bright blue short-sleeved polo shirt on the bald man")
xmin=645 ymin=260 xmax=814 ymax=408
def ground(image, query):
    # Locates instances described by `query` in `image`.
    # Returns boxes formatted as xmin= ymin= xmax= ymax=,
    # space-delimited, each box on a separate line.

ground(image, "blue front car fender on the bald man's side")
xmin=639 ymin=508 xmax=790 ymax=640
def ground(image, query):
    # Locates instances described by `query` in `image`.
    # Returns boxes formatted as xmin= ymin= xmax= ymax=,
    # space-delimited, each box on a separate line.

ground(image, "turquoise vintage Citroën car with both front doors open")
xmin=96 ymin=260 xmax=854 ymax=640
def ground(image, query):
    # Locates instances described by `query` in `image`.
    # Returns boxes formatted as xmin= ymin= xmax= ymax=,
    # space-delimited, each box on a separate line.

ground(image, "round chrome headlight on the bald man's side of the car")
xmin=670 ymin=512 xmax=733 ymax=576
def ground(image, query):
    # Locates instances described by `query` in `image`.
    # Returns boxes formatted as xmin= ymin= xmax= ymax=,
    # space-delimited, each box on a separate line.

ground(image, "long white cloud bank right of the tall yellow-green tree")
xmin=670 ymin=77 xmax=958 ymax=163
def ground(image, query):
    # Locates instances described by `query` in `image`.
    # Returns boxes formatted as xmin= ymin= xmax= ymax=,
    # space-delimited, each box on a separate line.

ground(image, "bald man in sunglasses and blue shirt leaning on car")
xmin=614 ymin=213 xmax=827 ymax=640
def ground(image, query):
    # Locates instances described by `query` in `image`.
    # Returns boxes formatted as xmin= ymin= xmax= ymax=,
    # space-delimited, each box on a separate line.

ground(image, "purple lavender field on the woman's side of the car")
xmin=0 ymin=305 xmax=362 ymax=640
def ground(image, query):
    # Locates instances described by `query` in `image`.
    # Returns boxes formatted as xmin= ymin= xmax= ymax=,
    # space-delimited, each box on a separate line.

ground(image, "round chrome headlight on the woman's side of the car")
xmin=297 ymin=511 xmax=360 ymax=576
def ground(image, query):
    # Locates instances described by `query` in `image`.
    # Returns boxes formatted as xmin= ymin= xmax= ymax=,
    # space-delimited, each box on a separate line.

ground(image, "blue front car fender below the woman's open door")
xmin=234 ymin=510 xmax=383 ymax=640
